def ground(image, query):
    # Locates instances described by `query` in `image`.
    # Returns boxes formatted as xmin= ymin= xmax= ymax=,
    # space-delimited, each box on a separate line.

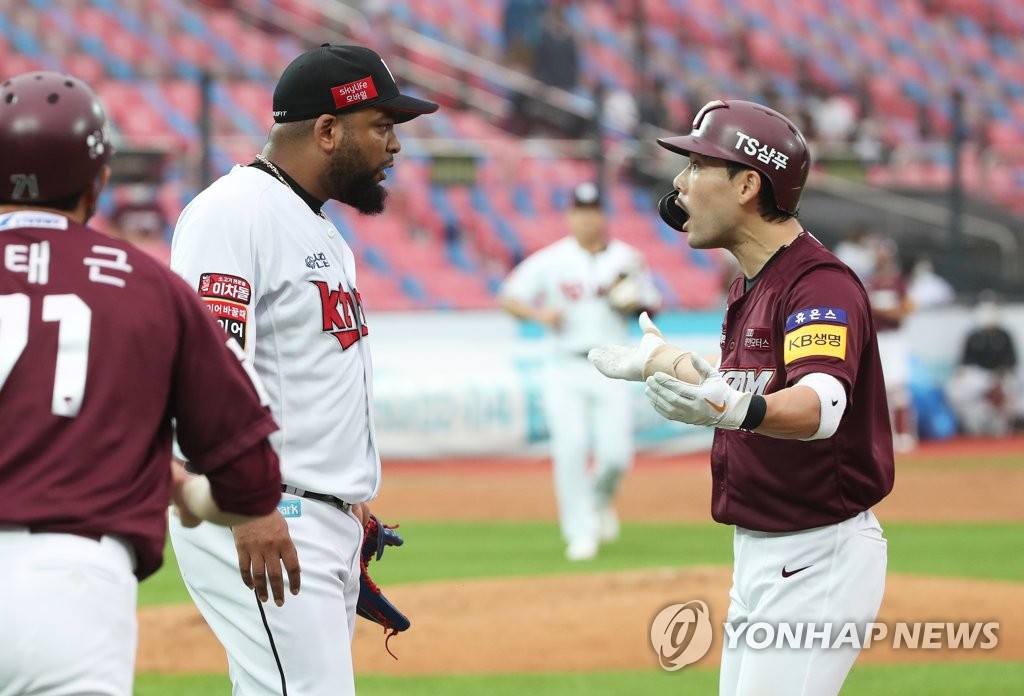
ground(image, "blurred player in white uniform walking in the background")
xmin=501 ymin=182 xmax=662 ymax=561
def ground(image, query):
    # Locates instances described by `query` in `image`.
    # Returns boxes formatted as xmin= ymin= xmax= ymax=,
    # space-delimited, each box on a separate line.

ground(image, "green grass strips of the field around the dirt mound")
xmin=135 ymin=446 xmax=1024 ymax=696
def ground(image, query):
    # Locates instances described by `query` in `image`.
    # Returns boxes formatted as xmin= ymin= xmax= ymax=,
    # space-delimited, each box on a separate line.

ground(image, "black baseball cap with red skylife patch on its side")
xmin=273 ymin=44 xmax=437 ymax=123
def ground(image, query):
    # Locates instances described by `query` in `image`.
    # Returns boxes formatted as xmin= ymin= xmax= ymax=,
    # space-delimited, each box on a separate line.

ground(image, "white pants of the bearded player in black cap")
xmin=171 ymin=493 xmax=362 ymax=696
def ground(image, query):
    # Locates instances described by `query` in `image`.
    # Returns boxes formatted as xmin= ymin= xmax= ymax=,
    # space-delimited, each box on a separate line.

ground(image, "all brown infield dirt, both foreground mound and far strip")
xmin=137 ymin=433 xmax=1024 ymax=675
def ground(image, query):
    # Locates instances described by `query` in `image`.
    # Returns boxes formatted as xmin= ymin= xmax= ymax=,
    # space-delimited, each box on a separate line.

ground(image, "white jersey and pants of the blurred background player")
xmin=502 ymin=236 xmax=660 ymax=550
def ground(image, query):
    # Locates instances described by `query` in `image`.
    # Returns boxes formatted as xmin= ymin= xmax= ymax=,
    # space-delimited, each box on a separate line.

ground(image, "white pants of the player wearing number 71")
xmin=0 ymin=527 xmax=138 ymax=696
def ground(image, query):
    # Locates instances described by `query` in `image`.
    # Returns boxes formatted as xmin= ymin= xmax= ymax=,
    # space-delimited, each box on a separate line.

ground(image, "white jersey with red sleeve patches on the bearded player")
xmin=171 ymin=166 xmax=380 ymax=503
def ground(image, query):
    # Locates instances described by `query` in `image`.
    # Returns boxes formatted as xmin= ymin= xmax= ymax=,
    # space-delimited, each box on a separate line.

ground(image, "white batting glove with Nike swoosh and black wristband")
xmin=644 ymin=353 xmax=753 ymax=430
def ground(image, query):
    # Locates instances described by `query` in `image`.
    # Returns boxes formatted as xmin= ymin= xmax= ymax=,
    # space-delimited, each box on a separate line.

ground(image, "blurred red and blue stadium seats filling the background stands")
xmin=0 ymin=0 xmax=1024 ymax=306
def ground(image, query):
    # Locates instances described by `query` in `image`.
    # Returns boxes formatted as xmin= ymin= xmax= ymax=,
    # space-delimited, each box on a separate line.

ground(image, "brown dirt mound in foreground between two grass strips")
xmin=137 ymin=566 xmax=1024 ymax=675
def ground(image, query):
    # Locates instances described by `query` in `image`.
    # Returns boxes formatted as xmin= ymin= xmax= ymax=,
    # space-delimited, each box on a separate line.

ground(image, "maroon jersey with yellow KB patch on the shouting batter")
xmin=712 ymin=232 xmax=894 ymax=532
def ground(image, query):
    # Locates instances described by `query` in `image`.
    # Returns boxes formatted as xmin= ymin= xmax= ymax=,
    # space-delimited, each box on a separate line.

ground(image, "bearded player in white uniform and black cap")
xmin=171 ymin=44 xmax=437 ymax=696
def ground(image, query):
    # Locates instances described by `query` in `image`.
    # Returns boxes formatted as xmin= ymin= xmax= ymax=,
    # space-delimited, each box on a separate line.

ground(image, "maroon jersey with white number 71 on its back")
xmin=0 ymin=211 xmax=281 ymax=579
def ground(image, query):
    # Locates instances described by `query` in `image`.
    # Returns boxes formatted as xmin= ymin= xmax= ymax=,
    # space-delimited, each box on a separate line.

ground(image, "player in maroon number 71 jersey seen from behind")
xmin=0 ymin=73 xmax=283 ymax=696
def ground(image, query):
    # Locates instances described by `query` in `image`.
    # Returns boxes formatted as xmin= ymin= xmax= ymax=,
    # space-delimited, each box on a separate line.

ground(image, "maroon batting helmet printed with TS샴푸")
xmin=657 ymin=99 xmax=811 ymax=215
